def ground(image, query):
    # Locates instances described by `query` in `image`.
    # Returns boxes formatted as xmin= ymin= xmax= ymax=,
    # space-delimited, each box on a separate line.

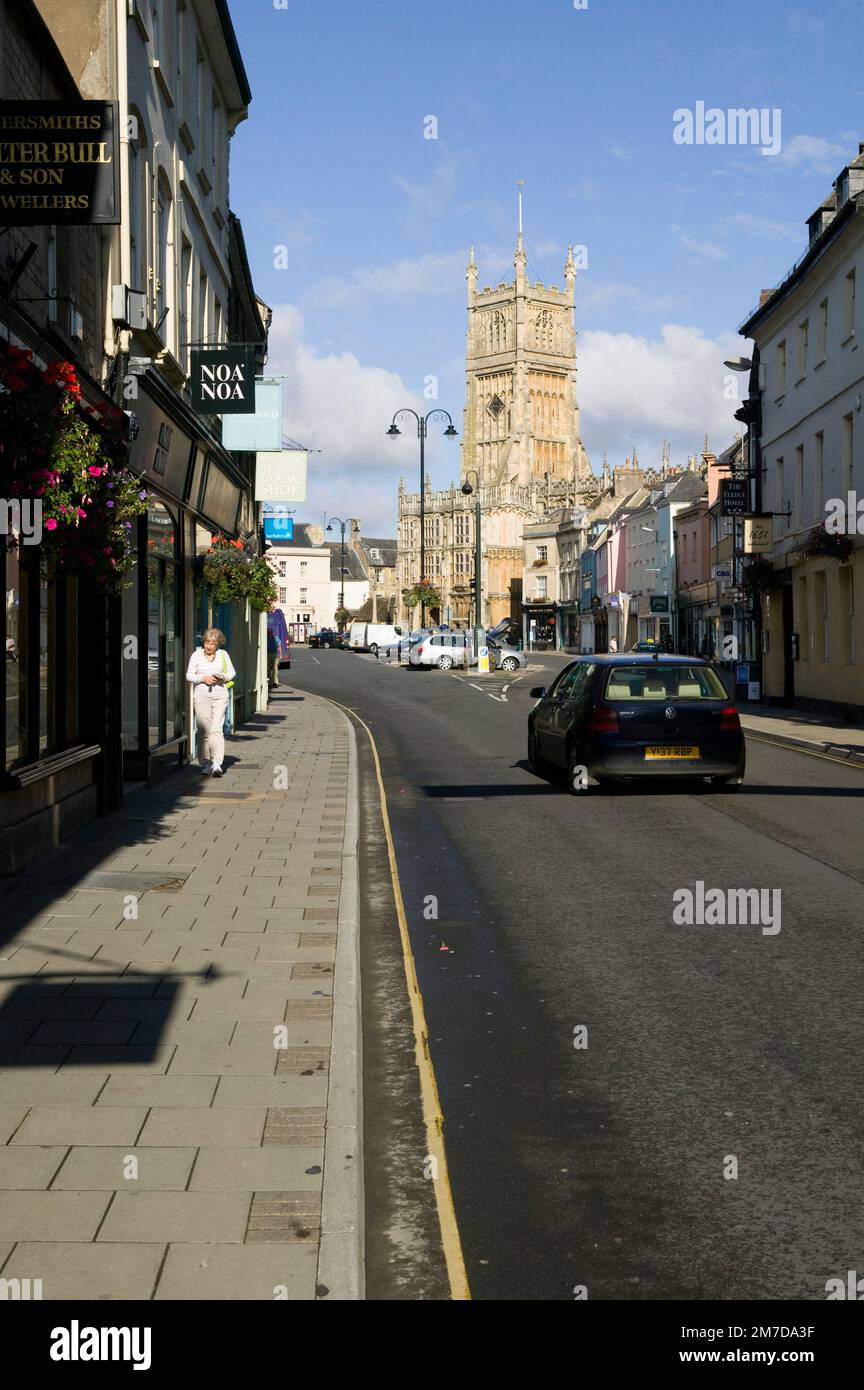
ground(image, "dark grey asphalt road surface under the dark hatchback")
xmin=283 ymin=649 xmax=864 ymax=1300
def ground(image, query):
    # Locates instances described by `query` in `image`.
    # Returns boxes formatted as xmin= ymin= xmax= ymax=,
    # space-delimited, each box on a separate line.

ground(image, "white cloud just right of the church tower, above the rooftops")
xmin=579 ymin=324 xmax=742 ymax=468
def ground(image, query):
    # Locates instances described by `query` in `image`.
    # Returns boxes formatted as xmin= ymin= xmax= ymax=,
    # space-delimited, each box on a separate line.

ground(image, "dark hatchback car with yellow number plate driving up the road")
xmin=528 ymin=652 xmax=746 ymax=792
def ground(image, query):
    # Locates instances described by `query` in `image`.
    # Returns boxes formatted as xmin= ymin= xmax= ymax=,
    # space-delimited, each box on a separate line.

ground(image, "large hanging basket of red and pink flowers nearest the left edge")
xmin=0 ymin=343 xmax=149 ymax=594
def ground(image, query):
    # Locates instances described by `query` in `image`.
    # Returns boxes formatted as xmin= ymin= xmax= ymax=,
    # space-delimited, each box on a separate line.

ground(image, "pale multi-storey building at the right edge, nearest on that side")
xmin=740 ymin=145 xmax=864 ymax=717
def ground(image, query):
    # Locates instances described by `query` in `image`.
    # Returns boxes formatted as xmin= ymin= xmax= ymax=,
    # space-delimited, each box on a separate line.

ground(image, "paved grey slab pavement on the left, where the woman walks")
xmin=0 ymin=689 xmax=364 ymax=1300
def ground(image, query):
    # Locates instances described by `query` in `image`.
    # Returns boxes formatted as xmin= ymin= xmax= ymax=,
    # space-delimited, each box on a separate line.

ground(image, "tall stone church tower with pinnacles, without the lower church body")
xmin=461 ymin=202 xmax=592 ymax=493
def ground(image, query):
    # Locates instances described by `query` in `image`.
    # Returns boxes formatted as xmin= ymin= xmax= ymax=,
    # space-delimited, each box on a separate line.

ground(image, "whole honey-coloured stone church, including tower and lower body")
xmin=397 ymin=229 xmax=599 ymax=627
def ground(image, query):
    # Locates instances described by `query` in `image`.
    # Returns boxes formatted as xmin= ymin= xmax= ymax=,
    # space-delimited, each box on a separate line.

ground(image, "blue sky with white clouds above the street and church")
xmin=231 ymin=0 xmax=864 ymax=535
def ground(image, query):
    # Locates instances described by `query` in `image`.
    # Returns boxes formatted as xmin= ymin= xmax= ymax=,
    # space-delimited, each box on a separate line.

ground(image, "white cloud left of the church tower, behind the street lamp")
xmin=267 ymin=304 xmax=425 ymax=535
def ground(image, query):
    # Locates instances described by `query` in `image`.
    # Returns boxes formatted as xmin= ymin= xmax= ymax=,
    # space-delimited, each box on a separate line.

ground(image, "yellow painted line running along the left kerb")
xmin=325 ymin=701 xmax=471 ymax=1301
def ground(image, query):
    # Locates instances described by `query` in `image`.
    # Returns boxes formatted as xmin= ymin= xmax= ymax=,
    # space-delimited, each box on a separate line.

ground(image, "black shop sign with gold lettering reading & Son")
xmin=0 ymin=101 xmax=121 ymax=227
